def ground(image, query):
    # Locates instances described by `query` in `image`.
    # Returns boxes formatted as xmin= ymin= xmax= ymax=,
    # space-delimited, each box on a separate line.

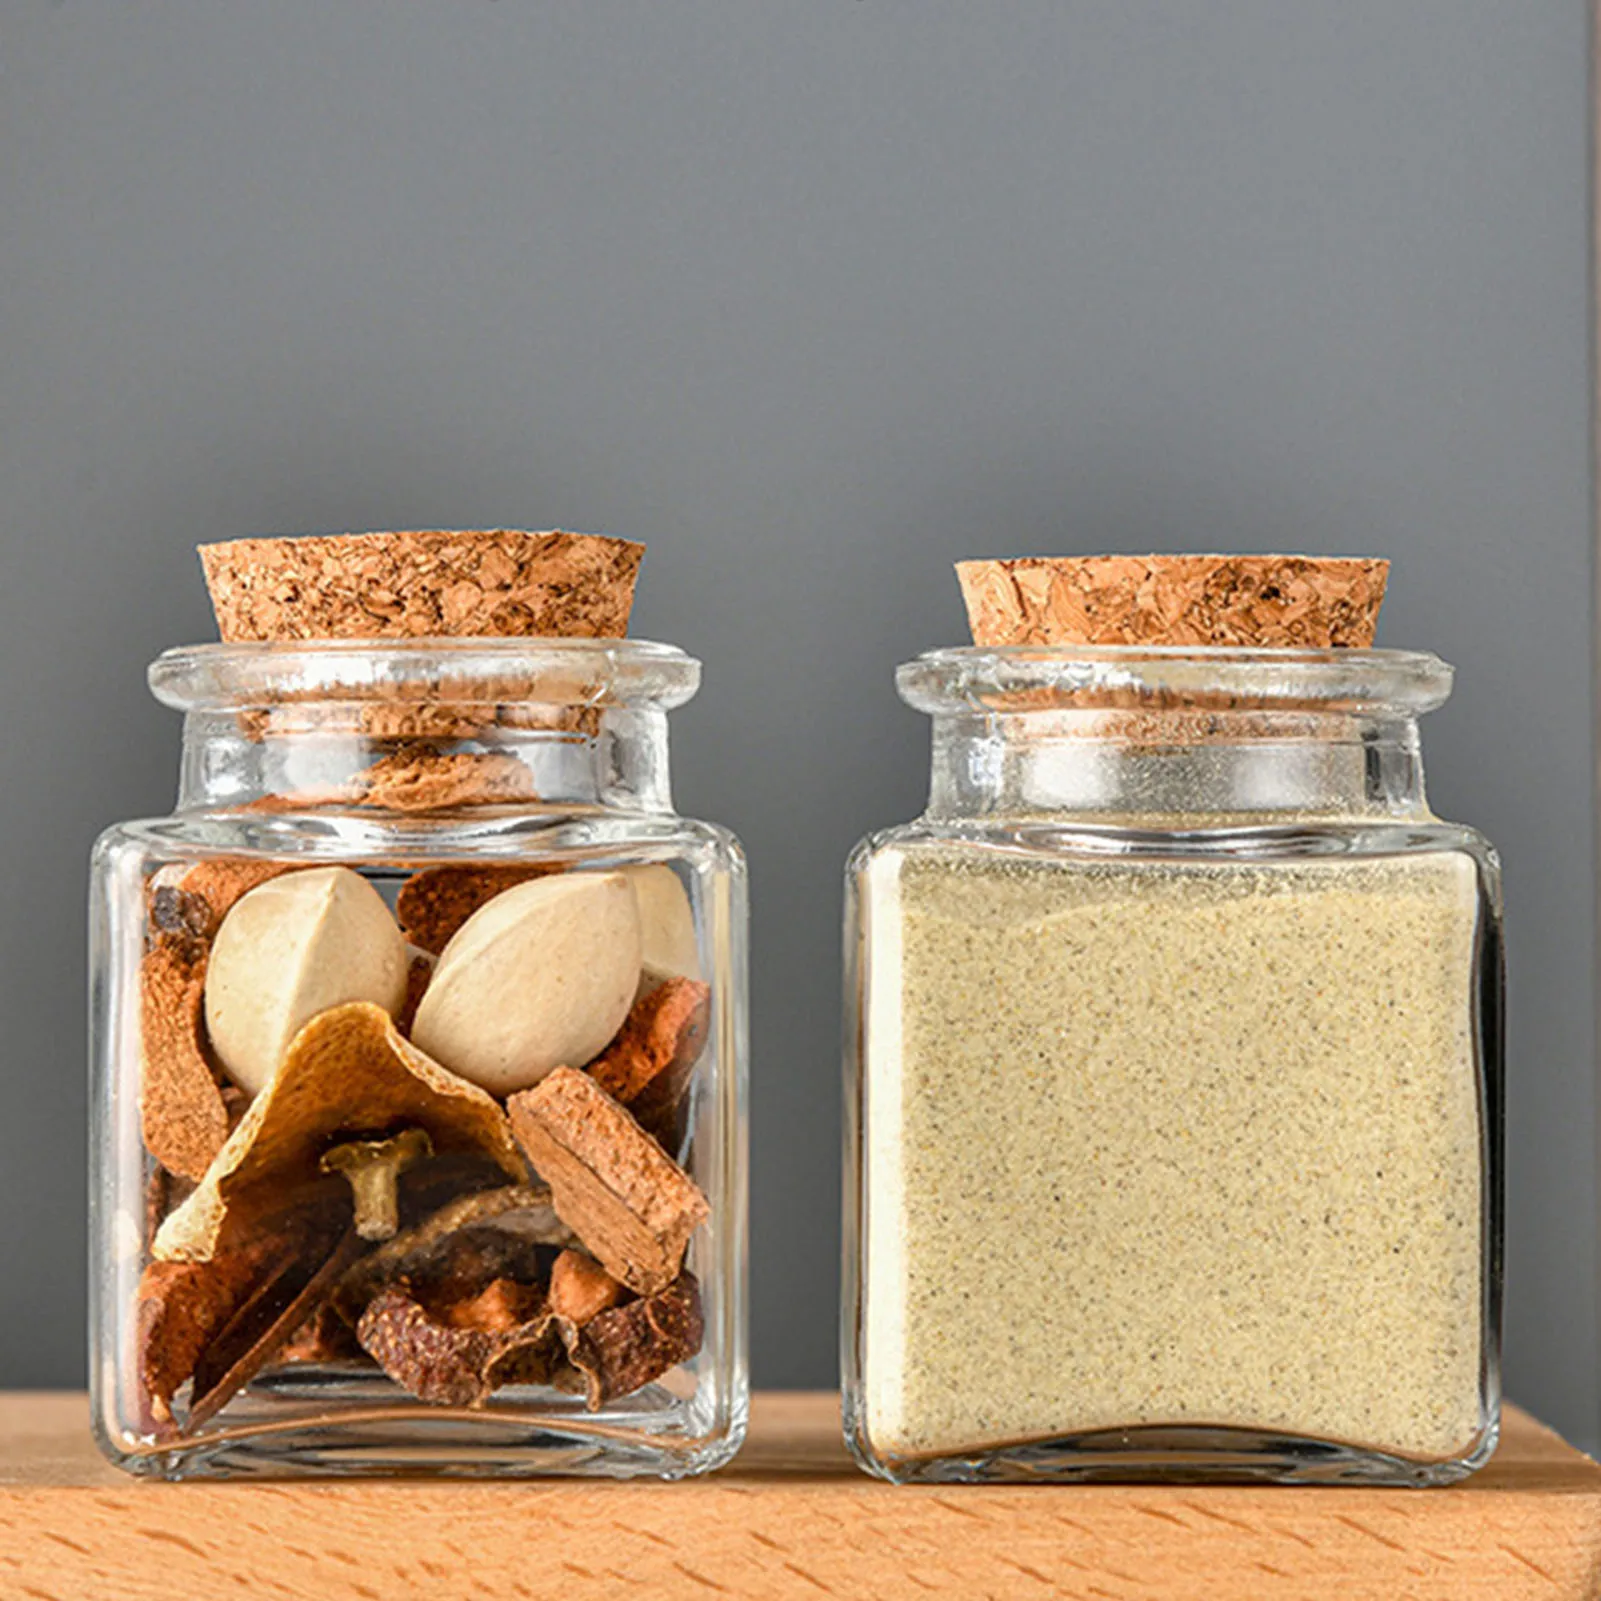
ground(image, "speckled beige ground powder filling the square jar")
xmin=863 ymin=845 xmax=1483 ymax=1457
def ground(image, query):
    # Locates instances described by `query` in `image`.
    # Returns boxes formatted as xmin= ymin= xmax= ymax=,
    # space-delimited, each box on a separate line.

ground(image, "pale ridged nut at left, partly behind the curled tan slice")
xmin=205 ymin=868 xmax=410 ymax=1095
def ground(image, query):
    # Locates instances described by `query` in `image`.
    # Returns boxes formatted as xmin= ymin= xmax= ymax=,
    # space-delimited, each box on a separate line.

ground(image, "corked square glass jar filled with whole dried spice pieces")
xmin=91 ymin=530 xmax=748 ymax=1478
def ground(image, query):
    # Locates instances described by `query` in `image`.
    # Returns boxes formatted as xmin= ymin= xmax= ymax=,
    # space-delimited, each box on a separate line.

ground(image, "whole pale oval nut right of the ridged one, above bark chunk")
xmin=411 ymin=873 xmax=642 ymax=1095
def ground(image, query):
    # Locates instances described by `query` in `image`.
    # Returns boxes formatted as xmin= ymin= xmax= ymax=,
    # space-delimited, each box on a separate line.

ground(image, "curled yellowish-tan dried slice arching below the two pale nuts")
xmin=154 ymin=1001 xmax=527 ymax=1262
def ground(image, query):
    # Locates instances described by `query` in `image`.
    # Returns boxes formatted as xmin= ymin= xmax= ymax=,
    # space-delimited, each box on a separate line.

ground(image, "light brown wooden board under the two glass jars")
xmin=0 ymin=1394 xmax=1601 ymax=1601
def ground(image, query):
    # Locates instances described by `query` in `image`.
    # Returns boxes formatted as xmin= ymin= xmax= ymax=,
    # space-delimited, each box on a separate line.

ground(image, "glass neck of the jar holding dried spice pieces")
xmin=178 ymin=704 xmax=672 ymax=813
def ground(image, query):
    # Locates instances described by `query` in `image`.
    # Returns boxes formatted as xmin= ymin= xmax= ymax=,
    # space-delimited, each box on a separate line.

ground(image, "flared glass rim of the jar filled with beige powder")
xmin=895 ymin=645 xmax=1455 ymax=717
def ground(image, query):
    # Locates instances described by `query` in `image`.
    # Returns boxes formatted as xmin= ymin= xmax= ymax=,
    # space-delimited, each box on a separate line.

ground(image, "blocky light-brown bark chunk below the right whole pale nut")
xmin=508 ymin=1068 xmax=709 ymax=1295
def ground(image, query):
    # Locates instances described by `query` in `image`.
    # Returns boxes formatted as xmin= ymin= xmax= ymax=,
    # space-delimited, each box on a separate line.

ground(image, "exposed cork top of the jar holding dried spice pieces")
xmin=200 ymin=528 xmax=645 ymax=644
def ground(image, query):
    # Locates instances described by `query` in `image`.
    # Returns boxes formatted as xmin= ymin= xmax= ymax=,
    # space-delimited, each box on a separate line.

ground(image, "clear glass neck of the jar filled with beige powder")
xmin=925 ymin=709 xmax=1430 ymax=828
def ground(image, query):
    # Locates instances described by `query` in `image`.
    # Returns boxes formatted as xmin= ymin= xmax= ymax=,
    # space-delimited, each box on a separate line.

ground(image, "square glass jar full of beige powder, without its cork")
xmin=842 ymin=645 xmax=1502 ymax=1484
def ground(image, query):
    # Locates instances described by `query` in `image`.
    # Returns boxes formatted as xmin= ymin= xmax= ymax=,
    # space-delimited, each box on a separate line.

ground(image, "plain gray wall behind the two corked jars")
xmin=0 ymin=0 xmax=1596 ymax=1438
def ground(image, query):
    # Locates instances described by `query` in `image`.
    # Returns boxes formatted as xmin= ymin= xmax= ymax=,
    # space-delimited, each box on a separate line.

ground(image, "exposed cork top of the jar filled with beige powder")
xmin=956 ymin=556 xmax=1390 ymax=650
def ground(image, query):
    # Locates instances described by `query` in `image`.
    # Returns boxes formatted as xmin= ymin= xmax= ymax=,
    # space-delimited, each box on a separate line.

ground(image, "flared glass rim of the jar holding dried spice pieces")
xmin=149 ymin=636 xmax=701 ymax=712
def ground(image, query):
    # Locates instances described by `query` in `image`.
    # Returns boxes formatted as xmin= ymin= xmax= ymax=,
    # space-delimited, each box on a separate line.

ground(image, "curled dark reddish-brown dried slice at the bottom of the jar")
xmin=355 ymin=1279 xmax=557 ymax=1406
